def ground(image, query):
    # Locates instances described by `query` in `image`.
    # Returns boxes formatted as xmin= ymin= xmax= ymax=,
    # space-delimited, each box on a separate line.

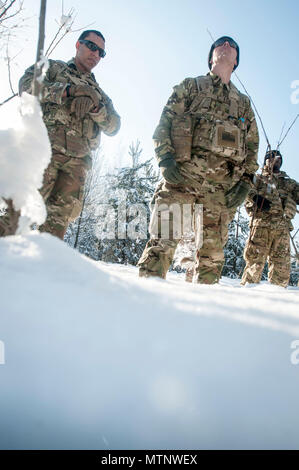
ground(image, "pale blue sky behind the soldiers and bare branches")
xmin=1 ymin=0 xmax=299 ymax=227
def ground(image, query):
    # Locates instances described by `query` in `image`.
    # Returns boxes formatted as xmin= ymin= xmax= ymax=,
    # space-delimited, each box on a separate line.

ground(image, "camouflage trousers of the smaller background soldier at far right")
xmin=241 ymin=220 xmax=290 ymax=287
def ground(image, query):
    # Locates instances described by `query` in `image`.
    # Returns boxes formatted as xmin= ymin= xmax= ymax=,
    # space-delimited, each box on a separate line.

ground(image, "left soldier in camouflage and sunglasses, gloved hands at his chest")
xmin=0 ymin=30 xmax=120 ymax=239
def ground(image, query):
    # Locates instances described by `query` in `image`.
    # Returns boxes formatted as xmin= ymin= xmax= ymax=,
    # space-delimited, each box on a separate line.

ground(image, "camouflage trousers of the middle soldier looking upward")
xmin=138 ymin=181 xmax=231 ymax=284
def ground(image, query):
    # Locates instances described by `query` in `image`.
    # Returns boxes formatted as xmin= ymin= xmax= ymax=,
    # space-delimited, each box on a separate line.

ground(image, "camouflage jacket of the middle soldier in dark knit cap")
xmin=153 ymin=73 xmax=259 ymax=182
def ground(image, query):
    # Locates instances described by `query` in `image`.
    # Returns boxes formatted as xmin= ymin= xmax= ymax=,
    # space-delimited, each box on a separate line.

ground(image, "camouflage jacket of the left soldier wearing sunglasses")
xmin=19 ymin=59 xmax=120 ymax=157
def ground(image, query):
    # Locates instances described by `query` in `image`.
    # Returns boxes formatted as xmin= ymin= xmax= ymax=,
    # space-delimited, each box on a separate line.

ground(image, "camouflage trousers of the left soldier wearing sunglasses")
xmin=0 ymin=153 xmax=91 ymax=240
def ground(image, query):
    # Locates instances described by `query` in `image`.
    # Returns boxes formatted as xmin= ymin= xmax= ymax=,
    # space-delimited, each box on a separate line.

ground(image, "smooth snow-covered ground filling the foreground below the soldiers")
xmin=0 ymin=233 xmax=299 ymax=449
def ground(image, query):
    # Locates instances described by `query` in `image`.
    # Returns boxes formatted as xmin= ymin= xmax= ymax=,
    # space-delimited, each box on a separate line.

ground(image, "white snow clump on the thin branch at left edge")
xmin=0 ymin=93 xmax=51 ymax=233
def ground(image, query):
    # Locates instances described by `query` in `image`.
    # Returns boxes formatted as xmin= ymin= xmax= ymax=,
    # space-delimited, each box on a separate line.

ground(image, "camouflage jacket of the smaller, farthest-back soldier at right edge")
xmin=245 ymin=168 xmax=299 ymax=230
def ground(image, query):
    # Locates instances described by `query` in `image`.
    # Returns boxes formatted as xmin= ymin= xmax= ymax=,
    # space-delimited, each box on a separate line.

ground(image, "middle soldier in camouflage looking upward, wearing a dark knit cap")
xmin=138 ymin=36 xmax=259 ymax=284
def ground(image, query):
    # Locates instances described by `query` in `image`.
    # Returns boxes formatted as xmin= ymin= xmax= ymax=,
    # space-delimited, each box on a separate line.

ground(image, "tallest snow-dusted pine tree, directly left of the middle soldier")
xmin=98 ymin=141 xmax=158 ymax=265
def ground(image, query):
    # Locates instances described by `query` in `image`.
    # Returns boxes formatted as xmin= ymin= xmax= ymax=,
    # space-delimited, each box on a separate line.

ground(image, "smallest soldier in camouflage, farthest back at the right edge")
xmin=241 ymin=150 xmax=299 ymax=287
